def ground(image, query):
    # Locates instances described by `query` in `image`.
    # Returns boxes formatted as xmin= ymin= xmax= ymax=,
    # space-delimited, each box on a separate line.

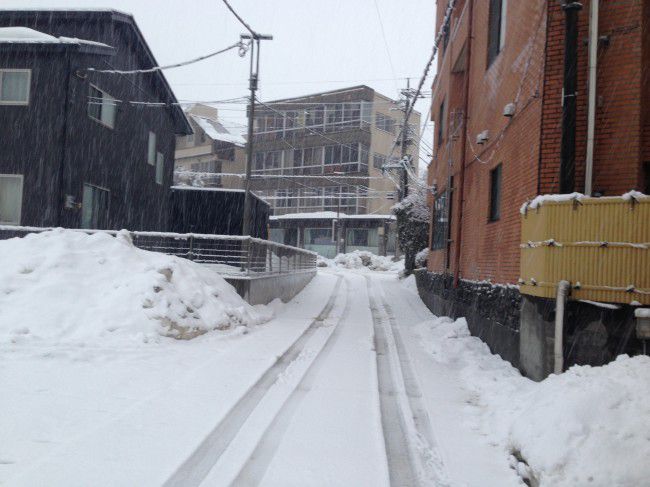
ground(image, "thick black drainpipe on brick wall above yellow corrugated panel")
xmin=560 ymin=2 xmax=582 ymax=194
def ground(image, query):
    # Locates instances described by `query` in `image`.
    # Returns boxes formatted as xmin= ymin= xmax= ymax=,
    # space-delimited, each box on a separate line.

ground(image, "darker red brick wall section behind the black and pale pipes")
xmin=539 ymin=0 xmax=647 ymax=196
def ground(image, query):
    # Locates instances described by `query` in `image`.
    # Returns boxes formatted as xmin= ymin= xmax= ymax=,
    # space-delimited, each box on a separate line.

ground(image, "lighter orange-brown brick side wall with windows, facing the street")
xmin=429 ymin=0 xmax=546 ymax=282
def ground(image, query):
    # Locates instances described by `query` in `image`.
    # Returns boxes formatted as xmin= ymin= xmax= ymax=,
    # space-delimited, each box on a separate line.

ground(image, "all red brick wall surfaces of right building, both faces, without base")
xmin=428 ymin=0 xmax=650 ymax=283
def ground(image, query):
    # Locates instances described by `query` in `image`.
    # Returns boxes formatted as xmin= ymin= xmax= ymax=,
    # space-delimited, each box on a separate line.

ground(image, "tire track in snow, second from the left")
xmin=231 ymin=279 xmax=352 ymax=486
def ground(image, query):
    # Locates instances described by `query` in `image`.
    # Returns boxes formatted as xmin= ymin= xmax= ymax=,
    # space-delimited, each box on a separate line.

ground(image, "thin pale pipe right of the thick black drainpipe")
xmin=585 ymin=0 xmax=600 ymax=196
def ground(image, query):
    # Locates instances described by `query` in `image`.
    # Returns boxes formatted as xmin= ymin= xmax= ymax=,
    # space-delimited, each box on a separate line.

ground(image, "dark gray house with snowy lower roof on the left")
xmin=0 ymin=10 xmax=192 ymax=230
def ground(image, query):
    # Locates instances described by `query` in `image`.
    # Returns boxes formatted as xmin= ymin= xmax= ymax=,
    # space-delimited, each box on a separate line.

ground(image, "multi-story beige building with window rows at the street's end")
xmin=252 ymin=86 xmax=420 ymax=256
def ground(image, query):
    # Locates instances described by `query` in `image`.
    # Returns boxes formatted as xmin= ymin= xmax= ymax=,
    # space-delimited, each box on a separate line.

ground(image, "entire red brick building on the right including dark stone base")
xmin=419 ymin=0 xmax=650 ymax=380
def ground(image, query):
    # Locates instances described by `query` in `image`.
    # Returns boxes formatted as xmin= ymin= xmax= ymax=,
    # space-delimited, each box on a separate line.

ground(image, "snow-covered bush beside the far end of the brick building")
xmin=392 ymin=184 xmax=431 ymax=275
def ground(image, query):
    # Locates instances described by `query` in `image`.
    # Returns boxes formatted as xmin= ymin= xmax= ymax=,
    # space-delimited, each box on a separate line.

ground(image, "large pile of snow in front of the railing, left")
xmin=0 ymin=229 xmax=270 ymax=345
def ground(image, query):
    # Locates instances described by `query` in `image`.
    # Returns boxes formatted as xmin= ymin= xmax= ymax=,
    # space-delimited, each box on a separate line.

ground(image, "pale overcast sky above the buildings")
xmin=8 ymin=0 xmax=436 ymax=162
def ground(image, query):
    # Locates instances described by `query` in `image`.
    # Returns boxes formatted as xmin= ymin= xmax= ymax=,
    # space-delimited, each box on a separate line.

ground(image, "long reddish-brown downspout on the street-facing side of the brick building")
xmin=454 ymin=0 xmax=474 ymax=287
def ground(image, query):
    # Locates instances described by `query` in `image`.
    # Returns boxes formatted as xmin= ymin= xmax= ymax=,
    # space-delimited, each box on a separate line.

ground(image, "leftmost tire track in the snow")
xmin=163 ymin=277 xmax=343 ymax=487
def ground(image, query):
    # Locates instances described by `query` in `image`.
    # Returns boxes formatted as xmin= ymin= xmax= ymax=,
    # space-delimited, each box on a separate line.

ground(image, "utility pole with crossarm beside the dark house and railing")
xmin=240 ymin=33 xmax=273 ymax=235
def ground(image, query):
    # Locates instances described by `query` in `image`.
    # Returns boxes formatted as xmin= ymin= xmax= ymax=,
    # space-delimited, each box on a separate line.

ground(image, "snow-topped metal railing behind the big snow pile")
xmin=0 ymin=225 xmax=317 ymax=279
